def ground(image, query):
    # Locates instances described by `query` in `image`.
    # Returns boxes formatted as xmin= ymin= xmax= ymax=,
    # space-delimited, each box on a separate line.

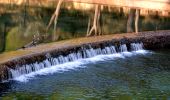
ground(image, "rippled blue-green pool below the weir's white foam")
xmin=0 ymin=50 xmax=170 ymax=100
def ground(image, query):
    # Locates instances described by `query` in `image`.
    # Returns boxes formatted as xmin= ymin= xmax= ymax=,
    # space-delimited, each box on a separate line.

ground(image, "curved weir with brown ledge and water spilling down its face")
xmin=0 ymin=30 xmax=170 ymax=82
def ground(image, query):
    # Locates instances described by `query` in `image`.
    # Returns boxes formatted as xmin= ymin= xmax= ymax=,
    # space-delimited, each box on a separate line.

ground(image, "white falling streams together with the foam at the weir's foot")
xmin=9 ymin=43 xmax=148 ymax=82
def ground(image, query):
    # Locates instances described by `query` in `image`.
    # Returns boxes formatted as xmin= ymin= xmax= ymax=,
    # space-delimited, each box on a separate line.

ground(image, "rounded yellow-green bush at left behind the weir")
xmin=6 ymin=22 xmax=45 ymax=51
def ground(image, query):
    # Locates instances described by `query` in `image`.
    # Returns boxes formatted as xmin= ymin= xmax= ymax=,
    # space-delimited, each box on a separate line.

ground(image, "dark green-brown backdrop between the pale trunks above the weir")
xmin=0 ymin=4 xmax=170 ymax=52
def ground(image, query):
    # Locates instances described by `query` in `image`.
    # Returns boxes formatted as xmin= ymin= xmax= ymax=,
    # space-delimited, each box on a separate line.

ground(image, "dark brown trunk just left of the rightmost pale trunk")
xmin=127 ymin=9 xmax=135 ymax=33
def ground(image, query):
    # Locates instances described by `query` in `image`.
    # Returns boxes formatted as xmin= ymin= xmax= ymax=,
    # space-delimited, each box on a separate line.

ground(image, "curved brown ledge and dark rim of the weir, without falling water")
xmin=0 ymin=30 xmax=170 ymax=80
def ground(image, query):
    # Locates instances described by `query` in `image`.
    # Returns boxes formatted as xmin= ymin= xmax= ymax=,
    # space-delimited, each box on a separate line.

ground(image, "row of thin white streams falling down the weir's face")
xmin=8 ymin=43 xmax=143 ymax=80
